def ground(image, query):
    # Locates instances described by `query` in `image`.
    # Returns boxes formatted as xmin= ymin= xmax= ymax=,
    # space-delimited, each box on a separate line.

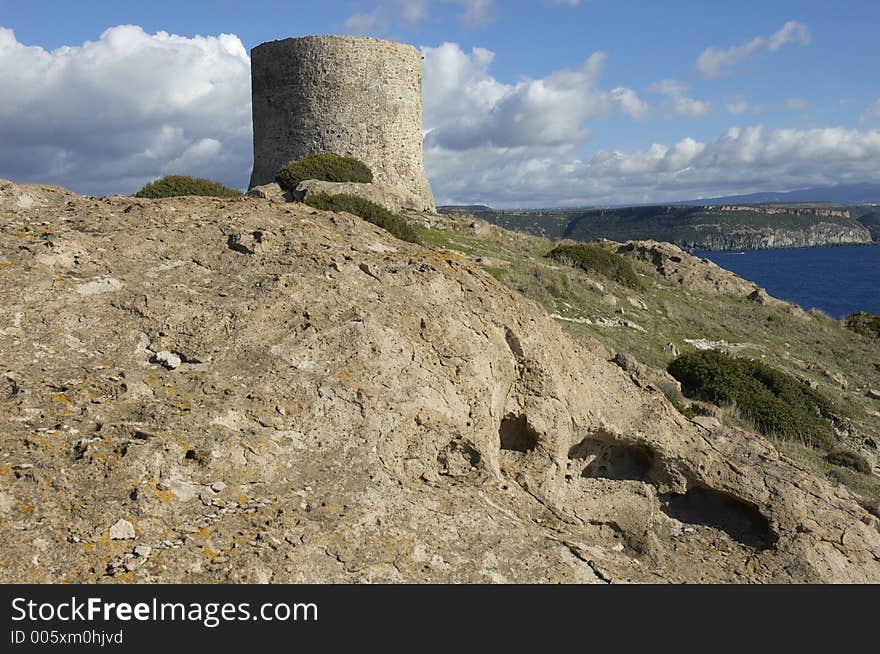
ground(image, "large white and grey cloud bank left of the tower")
xmin=0 ymin=25 xmax=252 ymax=193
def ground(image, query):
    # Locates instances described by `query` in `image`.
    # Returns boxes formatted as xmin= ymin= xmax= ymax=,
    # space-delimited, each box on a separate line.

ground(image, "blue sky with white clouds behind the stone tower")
xmin=0 ymin=0 xmax=880 ymax=206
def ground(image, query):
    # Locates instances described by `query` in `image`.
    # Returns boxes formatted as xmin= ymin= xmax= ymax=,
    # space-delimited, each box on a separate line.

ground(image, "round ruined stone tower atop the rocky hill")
xmin=250 ymin=36 xmax=434 ymax=211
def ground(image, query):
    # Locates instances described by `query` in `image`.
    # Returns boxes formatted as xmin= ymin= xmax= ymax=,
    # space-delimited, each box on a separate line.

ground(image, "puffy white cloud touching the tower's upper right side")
xmin=422 ymin=43 xmax=647 ymax=150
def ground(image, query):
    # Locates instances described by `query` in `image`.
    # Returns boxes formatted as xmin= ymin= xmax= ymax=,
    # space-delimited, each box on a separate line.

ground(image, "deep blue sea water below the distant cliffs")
xmin=694 ymin=246 xmax=880 ymax=318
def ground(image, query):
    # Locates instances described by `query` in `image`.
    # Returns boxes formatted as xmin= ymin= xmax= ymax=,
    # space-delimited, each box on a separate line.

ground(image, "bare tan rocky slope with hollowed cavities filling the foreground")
xmin=0 ymin=183 xmax=880 ymax=583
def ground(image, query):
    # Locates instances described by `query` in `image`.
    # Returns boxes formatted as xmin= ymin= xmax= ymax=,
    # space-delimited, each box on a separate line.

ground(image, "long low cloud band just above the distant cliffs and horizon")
xmin=429 ymin=126 xmax=880 ymax=206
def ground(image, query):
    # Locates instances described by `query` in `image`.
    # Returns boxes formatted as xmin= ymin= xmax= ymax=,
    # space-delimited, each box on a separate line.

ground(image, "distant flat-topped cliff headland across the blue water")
xmin=468 ymin=205 xmax=872 ymax=250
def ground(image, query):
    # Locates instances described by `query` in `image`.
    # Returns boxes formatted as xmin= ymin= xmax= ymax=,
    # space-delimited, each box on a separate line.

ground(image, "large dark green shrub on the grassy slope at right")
xmin=669 ymin=350 xmax=834 ymax=450
